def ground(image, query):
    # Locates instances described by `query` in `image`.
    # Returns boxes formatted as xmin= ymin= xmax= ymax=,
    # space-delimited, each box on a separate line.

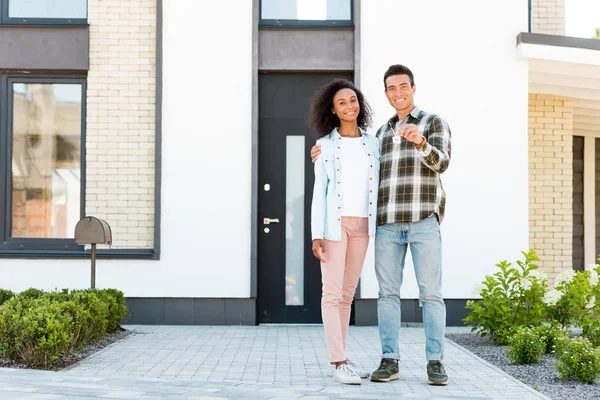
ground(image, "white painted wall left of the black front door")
xmin=0 ymin=0 xmax=252 ymax=297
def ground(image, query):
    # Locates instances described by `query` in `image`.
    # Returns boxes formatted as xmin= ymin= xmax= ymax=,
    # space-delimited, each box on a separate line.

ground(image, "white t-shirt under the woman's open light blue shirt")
xmin=340 ymin=137 xmax=369 ymax=217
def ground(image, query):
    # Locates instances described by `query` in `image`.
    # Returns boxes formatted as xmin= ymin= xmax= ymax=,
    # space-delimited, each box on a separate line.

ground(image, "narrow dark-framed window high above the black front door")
xmin=260 ymin=0 xmax=353 ymax=26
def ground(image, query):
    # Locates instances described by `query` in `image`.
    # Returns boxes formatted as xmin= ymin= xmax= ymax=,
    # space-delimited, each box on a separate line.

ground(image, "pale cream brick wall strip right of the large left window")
xmin=86 ymin=0 xmax=156 ymax=248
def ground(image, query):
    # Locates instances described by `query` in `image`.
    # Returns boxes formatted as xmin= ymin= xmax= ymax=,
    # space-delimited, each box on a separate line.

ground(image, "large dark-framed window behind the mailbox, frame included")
xmin=0 ymin=76 xmax=86 ymax=250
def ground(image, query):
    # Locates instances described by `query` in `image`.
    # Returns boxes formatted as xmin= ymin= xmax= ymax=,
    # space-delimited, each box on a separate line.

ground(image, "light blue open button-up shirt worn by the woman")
xmin=311 ymin=128 xmax=380 ymax=241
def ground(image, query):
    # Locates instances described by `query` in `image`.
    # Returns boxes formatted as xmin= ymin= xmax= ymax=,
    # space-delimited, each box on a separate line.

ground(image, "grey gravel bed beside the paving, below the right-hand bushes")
xmin=446 ymin=333 xmax=600 ymax=400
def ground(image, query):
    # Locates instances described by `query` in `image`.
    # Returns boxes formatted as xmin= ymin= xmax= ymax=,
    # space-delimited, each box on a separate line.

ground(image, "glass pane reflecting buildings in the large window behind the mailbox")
xmin=12 ymin=83 xmax=82 ymax=238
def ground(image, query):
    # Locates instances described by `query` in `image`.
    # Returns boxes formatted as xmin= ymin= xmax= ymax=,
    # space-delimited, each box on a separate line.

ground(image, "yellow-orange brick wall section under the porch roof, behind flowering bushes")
xmin=529 ymin=94 xmax=573 ymax=283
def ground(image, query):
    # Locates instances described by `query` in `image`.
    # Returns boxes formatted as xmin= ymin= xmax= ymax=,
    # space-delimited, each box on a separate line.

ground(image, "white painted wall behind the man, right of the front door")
xmin=360 ymin=0 xmax=528 ymax=298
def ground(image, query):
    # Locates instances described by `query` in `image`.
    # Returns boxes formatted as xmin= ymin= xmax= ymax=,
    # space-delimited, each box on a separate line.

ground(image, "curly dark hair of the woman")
xmin=309 ymin=79 xmax=373 ymax=138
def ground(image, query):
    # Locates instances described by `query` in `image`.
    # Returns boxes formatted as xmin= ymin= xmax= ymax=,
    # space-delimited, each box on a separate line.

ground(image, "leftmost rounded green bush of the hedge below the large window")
xmin=0 ymin=296 xmax=73 ymax=367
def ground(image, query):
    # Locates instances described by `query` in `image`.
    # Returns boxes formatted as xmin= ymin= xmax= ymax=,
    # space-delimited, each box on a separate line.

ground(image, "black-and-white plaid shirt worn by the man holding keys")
xmin=377 ymin=107 xmax=450 ymax=225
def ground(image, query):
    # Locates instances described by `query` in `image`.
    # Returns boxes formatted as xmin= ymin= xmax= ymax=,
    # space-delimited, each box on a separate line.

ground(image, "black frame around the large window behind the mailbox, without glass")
xmin=0 ymin=71 xmax=87 ymax=253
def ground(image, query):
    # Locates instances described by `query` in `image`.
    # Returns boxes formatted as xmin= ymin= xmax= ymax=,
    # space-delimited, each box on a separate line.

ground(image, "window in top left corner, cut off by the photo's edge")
xmin=0 ymin=0 xmax=87 ymax=24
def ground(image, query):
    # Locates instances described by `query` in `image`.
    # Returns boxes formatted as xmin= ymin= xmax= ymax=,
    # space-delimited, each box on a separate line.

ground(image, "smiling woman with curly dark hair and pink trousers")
xmin=311 ymin=79 xmax=379 ymax=384
